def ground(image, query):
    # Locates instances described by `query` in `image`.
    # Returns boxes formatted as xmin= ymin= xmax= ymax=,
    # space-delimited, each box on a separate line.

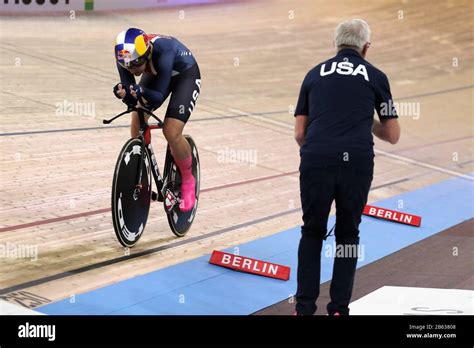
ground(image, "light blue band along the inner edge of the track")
xmin=37 ymin=178 xmax=474 ymax=315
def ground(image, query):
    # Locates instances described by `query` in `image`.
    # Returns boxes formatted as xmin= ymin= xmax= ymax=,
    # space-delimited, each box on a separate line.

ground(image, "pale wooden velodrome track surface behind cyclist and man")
xmin=0 ymin=0 xmax=474 ymax=307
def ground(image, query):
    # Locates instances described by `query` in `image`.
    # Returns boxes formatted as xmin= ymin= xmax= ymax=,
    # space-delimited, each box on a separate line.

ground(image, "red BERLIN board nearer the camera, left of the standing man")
xmin=209 ymin=250 xmax=290 ymax=280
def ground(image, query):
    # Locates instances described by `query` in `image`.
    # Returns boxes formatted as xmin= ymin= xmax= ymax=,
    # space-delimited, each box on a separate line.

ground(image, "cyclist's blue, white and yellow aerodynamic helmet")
xmin=115 ymin=28 xmax=151 ymax=68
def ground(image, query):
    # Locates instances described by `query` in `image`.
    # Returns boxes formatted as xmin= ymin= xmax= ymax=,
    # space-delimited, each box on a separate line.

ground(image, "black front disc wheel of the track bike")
xmin=112 ymin=138 xmax=151 ymax=248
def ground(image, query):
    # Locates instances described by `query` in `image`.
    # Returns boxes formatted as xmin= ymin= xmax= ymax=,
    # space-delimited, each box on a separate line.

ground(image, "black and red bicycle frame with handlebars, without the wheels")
xmin=103 ymin=106 xmax=166 ymax=201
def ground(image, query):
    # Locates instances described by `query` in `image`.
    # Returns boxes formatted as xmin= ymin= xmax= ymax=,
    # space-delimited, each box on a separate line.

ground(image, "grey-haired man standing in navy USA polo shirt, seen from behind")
xmin=295 ymin=19 xmax=400 ymax=315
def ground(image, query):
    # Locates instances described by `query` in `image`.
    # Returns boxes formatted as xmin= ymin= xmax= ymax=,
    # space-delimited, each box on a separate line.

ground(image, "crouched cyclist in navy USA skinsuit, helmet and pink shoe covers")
xmin=113 ymin=28 xmax=201 ymax=212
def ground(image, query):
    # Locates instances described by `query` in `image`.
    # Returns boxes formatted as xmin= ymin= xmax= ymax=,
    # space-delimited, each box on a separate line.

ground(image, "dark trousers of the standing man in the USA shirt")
xmin=296 ymin=162 xmax=373 ymax=315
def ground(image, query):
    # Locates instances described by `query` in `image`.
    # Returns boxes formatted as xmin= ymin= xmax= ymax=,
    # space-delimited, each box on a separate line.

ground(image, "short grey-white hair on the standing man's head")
xmin=334 ymin=19 xmax=370 ymax=51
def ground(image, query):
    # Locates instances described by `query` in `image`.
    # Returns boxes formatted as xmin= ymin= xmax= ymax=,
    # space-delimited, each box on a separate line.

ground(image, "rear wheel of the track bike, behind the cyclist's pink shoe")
xmin=163 ymin=135 xmax=201 ymax=237
